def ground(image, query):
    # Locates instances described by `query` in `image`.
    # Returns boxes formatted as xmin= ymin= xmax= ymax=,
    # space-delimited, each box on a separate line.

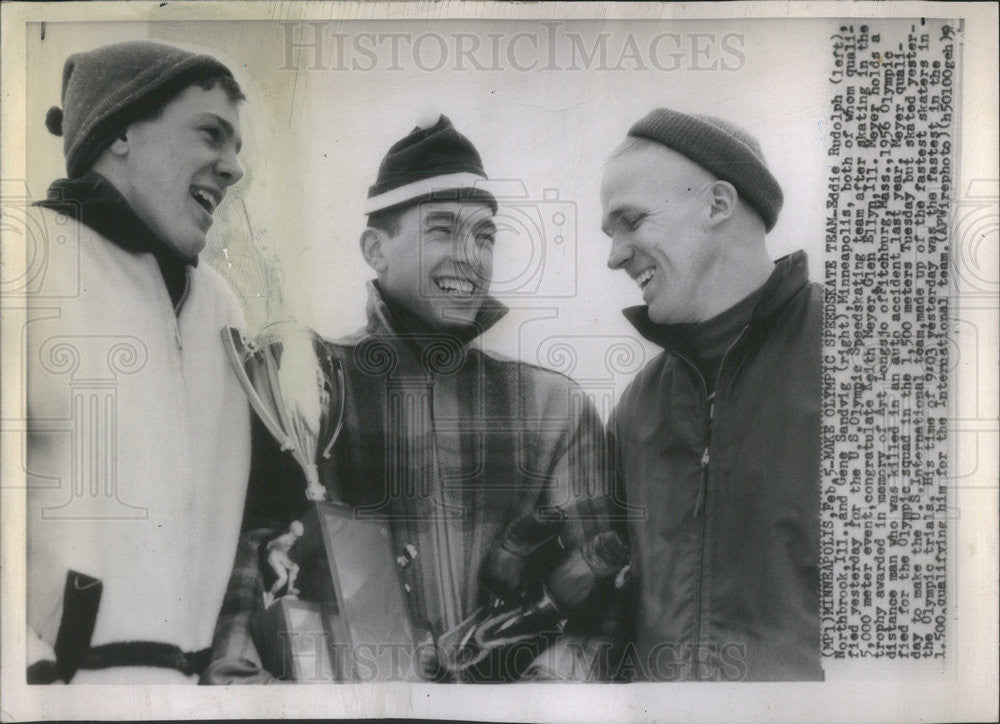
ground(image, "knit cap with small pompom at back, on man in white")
xmin=45 ymin=41 xmax=233 ymax=178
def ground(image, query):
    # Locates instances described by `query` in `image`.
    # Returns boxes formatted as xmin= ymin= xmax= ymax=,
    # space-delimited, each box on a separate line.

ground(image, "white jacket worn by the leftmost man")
xmin=26 ymin=209 xmax=250 ymax=681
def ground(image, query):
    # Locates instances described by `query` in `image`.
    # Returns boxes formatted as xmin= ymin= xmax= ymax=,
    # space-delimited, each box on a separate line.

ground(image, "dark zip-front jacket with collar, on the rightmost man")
xmin=610 ymin=252 xmax=823 ymax=681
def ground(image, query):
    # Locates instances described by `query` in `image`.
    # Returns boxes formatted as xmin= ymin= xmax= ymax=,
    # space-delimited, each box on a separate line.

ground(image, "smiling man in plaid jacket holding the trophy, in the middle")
xmin=205 ymin=116 xmax=626 ymax=683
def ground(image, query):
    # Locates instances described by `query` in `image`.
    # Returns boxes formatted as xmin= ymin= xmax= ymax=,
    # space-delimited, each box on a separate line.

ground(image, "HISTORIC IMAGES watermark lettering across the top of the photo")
xmin=278 ymin=21 xmax=747 ymax=73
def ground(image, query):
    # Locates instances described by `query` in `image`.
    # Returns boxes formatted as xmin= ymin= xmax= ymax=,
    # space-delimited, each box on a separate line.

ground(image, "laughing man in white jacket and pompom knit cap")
xmin=26 ymin=42 xmax=250 ymax=683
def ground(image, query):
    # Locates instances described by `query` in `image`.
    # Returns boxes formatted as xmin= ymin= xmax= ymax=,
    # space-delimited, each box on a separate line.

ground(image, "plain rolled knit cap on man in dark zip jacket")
xmin=628 ymin=108 xmax=784 ymax=231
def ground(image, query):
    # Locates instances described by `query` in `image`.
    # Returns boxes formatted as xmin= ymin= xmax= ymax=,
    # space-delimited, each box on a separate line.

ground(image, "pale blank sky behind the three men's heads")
xmin=28 ymin=19 xmax=837 ymax=415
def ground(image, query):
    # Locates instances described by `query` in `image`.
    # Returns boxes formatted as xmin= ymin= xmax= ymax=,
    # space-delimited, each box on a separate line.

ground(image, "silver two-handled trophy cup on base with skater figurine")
xmin=222 ymin=322 xmax=414 ymax=682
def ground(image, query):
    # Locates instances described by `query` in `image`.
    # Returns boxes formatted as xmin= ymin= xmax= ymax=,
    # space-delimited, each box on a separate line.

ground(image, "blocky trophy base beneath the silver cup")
xmin=257 ymin=502 xmax=420 ymax=682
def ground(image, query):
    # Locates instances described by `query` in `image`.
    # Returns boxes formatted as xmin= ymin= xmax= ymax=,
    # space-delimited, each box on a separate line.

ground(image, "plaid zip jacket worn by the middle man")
xmin=210 ymin=284 xmax=610 ymax=680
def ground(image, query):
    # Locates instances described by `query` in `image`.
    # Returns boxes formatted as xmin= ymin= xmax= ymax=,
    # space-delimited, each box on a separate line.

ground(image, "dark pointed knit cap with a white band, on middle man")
xmin=365 ymin=115 xmax=497 ymax=214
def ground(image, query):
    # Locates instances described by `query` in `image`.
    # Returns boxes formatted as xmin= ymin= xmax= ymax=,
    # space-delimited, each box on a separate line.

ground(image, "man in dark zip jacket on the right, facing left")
xmin=601 ymin=109 xmax=823 ymax=681
